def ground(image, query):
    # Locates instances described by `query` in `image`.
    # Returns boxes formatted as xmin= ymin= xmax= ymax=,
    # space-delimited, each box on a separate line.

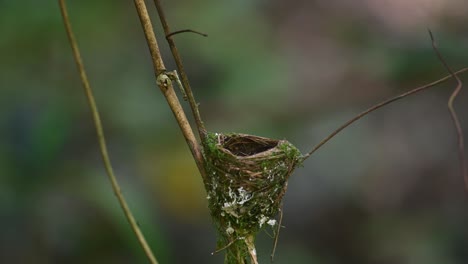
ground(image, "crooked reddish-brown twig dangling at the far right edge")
xmin=428 ymin=30 xmax=468 ymax=191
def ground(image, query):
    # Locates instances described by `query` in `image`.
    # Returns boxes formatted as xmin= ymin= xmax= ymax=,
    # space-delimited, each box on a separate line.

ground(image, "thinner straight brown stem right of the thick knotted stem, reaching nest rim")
xmin=154 ymin=0 xmax=206 ymax=142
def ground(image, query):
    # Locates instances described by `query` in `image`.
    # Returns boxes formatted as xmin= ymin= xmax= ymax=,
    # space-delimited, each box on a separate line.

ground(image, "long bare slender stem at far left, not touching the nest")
xmin=59 ymin=0 xmax=158 ymax=264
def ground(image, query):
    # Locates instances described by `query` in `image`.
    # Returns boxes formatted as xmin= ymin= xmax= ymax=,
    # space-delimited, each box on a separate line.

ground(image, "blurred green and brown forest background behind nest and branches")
xmin=0 ymin=0 xmax=468 ymax=264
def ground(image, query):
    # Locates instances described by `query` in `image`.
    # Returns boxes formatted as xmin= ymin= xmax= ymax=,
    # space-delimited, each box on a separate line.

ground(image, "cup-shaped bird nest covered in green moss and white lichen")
xmin=204 ymin=133 xmax=302 ymax=259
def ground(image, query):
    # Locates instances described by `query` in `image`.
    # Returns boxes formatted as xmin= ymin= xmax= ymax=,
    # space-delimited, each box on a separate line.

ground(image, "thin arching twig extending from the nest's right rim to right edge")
xmin=303 ymin=68 xmax=468 ymax=160
